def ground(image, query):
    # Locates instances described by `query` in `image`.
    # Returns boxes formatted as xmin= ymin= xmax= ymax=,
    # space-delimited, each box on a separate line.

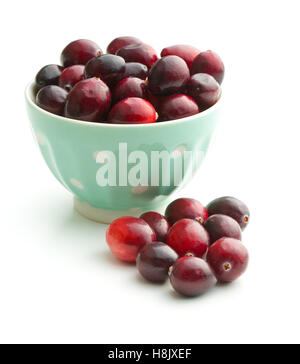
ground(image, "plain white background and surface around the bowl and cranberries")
xmin=0 ymin=0 xmax=300 ymax=343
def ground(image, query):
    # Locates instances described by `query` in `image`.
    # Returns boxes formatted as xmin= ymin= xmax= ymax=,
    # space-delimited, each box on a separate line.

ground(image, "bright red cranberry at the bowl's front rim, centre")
xmin=108 ymin=97 xmax=157 ymax=124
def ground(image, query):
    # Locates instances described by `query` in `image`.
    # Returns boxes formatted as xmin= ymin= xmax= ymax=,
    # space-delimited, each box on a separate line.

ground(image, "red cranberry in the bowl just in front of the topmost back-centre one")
xmin=116 ymin=43 xmax=158 ymax=69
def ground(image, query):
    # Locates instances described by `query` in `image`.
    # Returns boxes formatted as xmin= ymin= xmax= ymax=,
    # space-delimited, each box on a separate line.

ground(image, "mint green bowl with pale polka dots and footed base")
xmin=25 ymin=83 xmax=221 ymax=223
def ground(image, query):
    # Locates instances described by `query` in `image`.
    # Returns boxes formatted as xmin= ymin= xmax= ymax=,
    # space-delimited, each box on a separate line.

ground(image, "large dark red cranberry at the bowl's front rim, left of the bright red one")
xmin=65 ymin=78 xmax=111 ymax=122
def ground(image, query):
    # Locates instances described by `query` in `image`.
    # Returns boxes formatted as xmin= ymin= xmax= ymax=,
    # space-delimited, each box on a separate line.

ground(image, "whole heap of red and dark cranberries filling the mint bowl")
xmin=35 ymin=37 xmax=224 ymax=124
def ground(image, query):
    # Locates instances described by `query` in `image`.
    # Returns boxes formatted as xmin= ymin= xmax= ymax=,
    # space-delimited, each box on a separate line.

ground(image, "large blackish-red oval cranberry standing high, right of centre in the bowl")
xmin=148 ymin=56 xmax=190 ymax=95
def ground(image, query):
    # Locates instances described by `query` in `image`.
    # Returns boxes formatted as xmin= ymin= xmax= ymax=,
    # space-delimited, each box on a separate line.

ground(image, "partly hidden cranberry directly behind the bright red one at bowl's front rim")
xmin=113 ymin=77 xmax=146 ymax=102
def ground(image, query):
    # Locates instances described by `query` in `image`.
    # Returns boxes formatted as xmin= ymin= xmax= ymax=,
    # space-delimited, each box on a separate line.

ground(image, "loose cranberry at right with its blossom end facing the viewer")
xmin=207 ymin=238 xmax=249 ymax=282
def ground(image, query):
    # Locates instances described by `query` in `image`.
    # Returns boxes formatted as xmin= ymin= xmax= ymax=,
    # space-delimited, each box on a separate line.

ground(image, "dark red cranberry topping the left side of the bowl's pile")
xmin=60 ymin=39 xmax=102 ymax=67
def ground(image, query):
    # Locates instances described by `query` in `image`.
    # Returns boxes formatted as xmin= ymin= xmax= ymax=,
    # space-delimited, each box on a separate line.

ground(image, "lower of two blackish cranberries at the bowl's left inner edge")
xmin=36 ymin=85 xmax=68 ymax=115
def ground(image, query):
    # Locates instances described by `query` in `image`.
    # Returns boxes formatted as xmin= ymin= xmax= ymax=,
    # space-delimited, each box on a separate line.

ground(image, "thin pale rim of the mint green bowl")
xmin=25 ymin=81 xmax=223 ymax=129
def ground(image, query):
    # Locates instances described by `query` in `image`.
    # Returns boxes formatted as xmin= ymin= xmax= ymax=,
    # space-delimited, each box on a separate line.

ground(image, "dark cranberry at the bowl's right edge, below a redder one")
xmin=186 ymin=73 xmax=221 ymax=110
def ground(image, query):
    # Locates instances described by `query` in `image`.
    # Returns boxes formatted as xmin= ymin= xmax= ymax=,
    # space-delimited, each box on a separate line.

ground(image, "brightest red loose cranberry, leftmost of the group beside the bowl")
xmin=106 ymin=216 xmax=156 ymax=262
